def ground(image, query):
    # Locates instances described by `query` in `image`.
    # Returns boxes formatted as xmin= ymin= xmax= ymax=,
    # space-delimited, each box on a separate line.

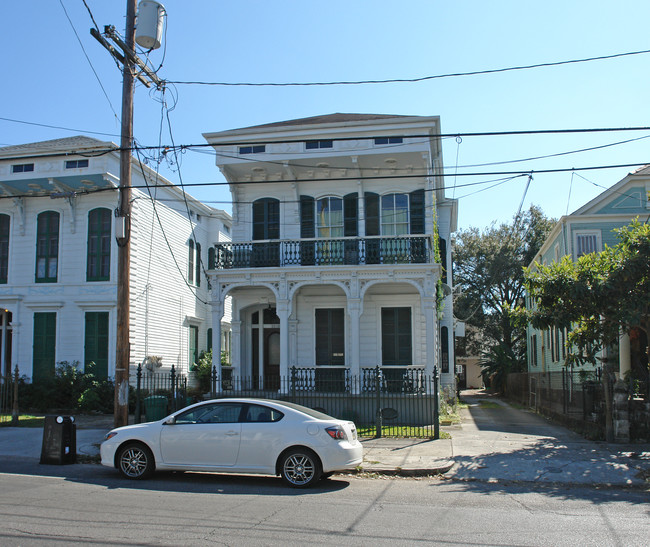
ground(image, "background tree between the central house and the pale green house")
xmin=454 ymin=206 xmax=555 ymax=387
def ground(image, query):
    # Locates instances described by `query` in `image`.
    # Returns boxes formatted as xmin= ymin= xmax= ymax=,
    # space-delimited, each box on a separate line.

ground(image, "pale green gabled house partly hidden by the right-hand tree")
xmin=527 ymin=166 xmax=650 ymax=380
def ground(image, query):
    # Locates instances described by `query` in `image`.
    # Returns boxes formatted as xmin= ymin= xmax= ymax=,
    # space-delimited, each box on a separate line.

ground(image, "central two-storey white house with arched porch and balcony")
xmin=204 ymin=114 xmax=457 ymax=390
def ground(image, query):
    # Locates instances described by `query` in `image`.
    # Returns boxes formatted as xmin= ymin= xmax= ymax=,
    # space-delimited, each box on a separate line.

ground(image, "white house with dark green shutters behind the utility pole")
xmin=0 ymin=137 xmax=231 ymax=382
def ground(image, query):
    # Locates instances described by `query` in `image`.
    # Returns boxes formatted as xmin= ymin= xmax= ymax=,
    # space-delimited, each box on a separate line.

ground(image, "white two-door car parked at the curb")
xmin=101 ymin=399 xmax=363 ymax=488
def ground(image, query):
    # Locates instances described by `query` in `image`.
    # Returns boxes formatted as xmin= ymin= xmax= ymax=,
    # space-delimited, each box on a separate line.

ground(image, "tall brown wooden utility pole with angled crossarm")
xmin=90 ymin=0 xmax=164 ymax=427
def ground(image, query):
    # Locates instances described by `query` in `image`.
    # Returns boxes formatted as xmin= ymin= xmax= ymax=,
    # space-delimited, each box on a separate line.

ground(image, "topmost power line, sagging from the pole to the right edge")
xmin=167 ymin=49 xmax=650 ymax=87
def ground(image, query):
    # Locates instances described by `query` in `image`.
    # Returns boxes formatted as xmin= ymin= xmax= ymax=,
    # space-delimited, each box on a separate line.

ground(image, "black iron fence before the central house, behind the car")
xmin=210 ymin=367 xmax=440 ymax=439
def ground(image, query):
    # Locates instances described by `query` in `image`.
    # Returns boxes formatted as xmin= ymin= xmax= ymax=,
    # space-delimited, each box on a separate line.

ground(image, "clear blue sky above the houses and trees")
xmin=0 ymin=0 xmax=650 ymax=229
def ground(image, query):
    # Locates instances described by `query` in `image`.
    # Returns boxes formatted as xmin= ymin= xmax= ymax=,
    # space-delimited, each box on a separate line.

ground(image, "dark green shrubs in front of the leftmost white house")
xmin=18 ymin=361 xmax=115 ymax=414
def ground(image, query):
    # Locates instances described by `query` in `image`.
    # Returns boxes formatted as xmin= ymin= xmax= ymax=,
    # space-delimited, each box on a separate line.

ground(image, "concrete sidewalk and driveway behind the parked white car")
xmin=0 ymin=392 xmax=650 ymax=488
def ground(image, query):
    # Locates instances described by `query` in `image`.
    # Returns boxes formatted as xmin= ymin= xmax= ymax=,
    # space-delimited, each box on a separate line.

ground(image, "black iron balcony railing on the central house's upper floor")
xmin=208 ymin=236 xmax=433 ymax=270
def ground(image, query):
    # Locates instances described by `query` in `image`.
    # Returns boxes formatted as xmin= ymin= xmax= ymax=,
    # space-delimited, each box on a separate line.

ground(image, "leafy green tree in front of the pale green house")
xmin=526 ymin=221 xmax=650 ymax=441
